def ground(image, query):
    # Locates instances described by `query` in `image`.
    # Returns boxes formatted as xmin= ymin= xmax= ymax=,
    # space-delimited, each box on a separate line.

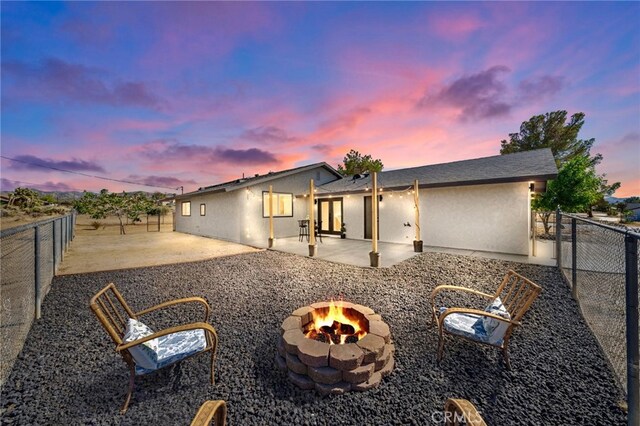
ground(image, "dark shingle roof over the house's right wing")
xmin=318 ymin=148 xmax=558 ymax=193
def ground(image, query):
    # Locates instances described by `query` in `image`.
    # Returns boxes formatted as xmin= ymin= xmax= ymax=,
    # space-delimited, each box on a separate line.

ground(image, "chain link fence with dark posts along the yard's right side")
xmin=552 ymin=212 xmax=640 ymax=424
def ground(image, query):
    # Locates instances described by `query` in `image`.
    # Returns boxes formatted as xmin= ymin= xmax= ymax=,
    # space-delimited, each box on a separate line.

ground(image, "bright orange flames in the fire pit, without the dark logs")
xmin=305 ymin=300 xmax=367 ymax=345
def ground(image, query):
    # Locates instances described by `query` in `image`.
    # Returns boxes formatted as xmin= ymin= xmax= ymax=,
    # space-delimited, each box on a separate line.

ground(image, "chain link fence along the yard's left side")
xmin=0 ymin=213 xmax=76 ymax=386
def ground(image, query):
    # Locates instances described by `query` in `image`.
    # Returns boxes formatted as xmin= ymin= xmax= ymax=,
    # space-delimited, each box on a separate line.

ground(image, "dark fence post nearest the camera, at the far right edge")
xmin=624 ymin=235 xmax=640 ymax=426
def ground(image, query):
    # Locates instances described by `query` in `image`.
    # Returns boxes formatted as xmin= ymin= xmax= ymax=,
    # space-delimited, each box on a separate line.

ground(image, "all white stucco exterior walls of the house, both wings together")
xmin=176 ymin=169 xmax=531 ymax=255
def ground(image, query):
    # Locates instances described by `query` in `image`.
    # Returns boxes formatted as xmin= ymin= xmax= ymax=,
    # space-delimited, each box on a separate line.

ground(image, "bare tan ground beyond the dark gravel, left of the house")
xmin=58 ymin=215 xmax=259 ymax=275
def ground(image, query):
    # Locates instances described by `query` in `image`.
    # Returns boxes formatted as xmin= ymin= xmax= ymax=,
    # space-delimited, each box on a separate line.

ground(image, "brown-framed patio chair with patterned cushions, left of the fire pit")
xmin=89 ymin=283 xmax=218 ymax=414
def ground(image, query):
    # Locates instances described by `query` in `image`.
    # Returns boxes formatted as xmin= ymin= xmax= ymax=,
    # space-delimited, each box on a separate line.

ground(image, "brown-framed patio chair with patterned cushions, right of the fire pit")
xmin=431 ymin=270 xmax=542 ymax=369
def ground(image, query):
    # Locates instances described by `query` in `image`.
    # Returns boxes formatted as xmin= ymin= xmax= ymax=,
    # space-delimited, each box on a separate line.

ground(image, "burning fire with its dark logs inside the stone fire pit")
xmin=305 ymin=300 xmax=367 ymax=345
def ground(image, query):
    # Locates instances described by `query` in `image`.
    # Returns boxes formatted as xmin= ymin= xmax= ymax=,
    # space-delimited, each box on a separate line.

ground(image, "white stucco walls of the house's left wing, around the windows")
xmin=176 ymin=168 xmax=336 ymax=244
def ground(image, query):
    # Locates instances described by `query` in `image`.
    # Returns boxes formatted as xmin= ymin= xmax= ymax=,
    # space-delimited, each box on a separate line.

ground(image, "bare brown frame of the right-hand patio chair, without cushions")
xmin=431 ymin=270 xmax=542 ymax=370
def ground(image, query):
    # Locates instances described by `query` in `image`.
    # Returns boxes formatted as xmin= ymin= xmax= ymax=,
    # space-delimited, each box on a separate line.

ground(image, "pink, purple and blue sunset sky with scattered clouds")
xmin=1 ymin=2 xmax=640 ymax=197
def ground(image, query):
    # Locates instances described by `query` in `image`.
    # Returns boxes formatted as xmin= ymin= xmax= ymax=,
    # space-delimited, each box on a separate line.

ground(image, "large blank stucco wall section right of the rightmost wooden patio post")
xmin=420 ymin=182 xmax=531 ymax=255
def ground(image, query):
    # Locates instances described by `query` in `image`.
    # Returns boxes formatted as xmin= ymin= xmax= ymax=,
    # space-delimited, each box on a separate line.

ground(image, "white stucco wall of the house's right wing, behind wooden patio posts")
xmin=344 ymin=182 xmax=531 ymax=255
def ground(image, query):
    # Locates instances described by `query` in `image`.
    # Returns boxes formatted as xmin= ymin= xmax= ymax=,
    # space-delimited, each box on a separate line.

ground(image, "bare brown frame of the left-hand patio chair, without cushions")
xmin=89 ymin=283 xmax=218 ymax=414
